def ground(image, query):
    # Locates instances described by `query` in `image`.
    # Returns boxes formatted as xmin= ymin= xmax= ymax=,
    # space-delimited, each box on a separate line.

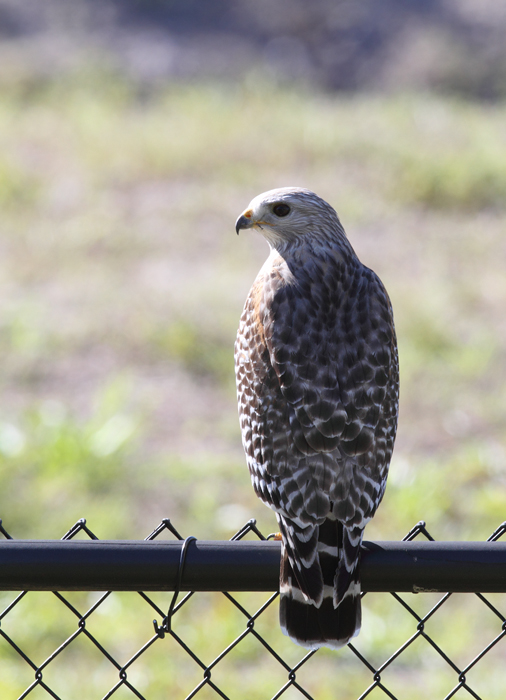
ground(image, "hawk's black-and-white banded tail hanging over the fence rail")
xmin=278 ymin=518 xmax=363 ymax=649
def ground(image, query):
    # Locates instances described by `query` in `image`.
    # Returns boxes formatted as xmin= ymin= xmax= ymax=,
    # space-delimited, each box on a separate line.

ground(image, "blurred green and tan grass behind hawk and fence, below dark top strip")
xmin=0 ymin=66 xmax=506 ymax=700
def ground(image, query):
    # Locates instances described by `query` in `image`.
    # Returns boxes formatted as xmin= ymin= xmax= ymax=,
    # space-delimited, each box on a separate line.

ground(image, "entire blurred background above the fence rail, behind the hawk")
xmin=0 ymin=0 xmax=506 ymax=699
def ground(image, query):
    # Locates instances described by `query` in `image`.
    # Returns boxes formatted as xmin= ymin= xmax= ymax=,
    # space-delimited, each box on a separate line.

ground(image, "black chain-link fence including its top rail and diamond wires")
xmin=0 ymin=520 xmax=506 ymax=700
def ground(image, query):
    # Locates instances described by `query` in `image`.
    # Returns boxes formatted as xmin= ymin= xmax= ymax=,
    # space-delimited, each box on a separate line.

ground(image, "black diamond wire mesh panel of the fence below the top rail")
xmin=0 ymin=519 xmax=506 ymax=700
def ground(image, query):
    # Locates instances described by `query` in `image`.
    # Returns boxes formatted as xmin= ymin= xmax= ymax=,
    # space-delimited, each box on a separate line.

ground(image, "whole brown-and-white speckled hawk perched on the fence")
xmin=235 ymin=187 xmax=399 ymax=649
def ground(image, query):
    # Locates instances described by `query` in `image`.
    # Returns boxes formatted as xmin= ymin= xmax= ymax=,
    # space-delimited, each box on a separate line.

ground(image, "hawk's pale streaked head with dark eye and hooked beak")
xmin=235 ymin=187 xmax=344 ymax=249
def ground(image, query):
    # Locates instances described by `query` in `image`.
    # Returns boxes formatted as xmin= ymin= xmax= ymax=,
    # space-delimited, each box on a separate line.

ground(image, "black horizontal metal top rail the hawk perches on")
xmin=0 ymin=539 xmax=506 ymax=593
